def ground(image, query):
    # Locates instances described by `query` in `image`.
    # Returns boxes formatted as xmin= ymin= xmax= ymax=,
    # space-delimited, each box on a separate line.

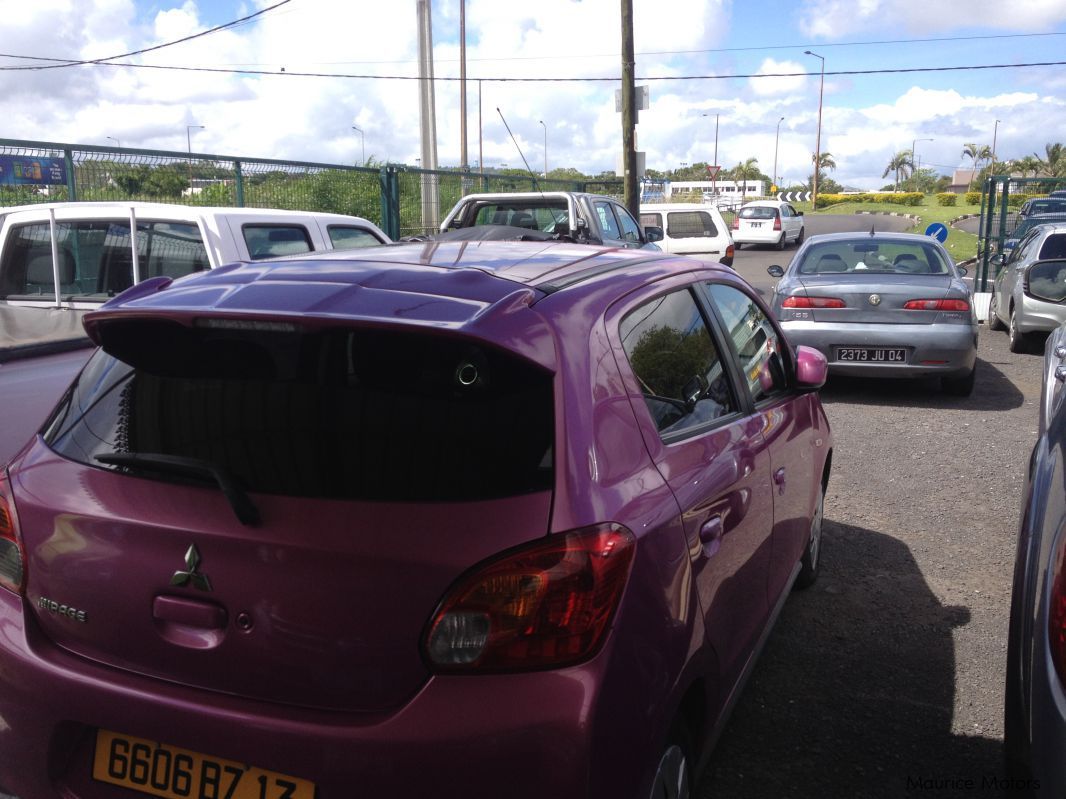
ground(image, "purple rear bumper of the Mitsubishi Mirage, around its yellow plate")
xmin=0 ymin=589 xmax=614 ymax=799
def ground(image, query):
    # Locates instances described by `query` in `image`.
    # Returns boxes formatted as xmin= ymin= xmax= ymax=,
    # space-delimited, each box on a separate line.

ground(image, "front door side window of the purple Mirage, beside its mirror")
xmin=706 ymin=283 xmax=788 ymax=403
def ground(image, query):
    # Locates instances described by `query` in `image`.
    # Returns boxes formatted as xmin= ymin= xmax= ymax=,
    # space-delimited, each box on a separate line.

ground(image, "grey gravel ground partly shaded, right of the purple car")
xmin=696 ymin=327 xmax=1041 ymax=799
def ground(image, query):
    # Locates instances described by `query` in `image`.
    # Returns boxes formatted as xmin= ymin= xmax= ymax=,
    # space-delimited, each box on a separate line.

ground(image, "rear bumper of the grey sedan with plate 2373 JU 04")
xmin=781 ymin=322 xmax=978 ymax=377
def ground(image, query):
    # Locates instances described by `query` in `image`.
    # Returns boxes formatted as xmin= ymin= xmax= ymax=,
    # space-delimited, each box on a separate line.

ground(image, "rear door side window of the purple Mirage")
xmin=618 ymin=289 xmax=739 ymax=437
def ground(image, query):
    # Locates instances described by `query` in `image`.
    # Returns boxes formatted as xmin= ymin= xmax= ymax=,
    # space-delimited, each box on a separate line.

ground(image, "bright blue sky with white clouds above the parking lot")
xmin=0 ymin=0 xmax=1066 ymax=189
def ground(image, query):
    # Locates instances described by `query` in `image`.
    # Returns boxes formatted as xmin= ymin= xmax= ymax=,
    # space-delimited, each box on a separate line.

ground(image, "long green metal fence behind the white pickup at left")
xmin=0 ymin=138 xmax=623 ymax=239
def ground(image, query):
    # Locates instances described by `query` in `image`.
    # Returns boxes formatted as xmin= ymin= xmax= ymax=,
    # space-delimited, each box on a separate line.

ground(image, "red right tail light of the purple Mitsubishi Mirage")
xmin=424 ymin=524 xmax=636 ymax=671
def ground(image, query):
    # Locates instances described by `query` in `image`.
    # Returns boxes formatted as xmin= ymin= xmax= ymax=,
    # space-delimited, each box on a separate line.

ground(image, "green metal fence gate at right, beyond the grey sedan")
xmin=974 ymin=175 xmax=1066 ymax=292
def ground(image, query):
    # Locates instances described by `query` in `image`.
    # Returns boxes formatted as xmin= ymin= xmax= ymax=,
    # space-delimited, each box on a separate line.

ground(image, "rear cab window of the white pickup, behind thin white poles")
xmin=0 ymin=219 xmax=210 ymax=301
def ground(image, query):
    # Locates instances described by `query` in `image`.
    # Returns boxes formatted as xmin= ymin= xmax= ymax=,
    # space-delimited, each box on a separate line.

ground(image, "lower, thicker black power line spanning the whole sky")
xmin=0 ymin=56 xmax=1066 ymax=83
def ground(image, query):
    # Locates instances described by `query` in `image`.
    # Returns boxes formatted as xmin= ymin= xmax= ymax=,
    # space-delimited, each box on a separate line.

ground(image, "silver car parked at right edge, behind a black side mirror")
xmin=988 ymin=224 xmax=1066 ymax=353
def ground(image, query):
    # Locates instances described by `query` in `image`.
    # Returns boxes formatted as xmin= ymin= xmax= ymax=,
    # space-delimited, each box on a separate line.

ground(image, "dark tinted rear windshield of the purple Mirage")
xmin=45 ymin=321 xmax=553 ymax=502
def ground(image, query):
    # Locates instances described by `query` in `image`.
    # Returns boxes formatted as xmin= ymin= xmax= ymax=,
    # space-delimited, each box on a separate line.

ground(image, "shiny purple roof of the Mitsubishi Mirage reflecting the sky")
xmin=85 ymin=241 xmax=732 ymax=338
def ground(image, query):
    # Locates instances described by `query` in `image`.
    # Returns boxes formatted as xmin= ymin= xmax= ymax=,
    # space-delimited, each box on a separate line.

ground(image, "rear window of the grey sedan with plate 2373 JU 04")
xmin=796 ymin=239 xmax=951 ymax=275
